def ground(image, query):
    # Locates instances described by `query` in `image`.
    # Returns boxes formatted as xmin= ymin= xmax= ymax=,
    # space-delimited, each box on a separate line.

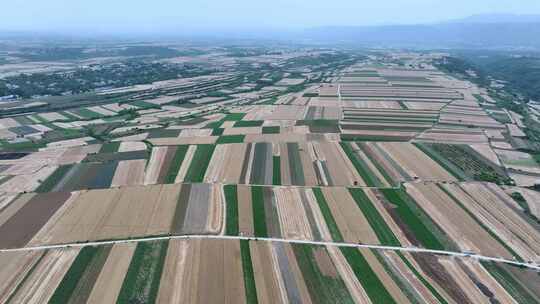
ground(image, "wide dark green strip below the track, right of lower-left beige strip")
xmin=116 ymin=241 xmax=169 ymax=304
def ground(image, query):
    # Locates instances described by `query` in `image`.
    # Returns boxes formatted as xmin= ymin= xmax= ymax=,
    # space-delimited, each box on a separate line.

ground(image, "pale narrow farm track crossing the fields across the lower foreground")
xmin=4 ymin=235 xmax=540 ymax=271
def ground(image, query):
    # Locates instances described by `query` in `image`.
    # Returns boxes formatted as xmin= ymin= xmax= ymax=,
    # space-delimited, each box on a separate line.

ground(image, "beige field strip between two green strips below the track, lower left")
xmin=86 ymin=243 xmax=136 ymax=304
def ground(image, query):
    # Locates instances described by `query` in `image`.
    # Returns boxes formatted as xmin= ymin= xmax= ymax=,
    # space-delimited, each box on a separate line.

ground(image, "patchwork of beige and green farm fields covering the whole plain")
xmin=0 ymin=46 xmax=540 ymax=304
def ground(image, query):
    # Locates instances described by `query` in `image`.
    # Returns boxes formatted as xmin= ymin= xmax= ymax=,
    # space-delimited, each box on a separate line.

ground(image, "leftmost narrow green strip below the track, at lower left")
xmin=49 ymin=247 xmax=99 ymax=304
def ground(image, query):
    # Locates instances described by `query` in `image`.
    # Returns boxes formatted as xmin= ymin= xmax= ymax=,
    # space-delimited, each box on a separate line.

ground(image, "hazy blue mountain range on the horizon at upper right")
xmin=303 ymin=14 xmax=540 ymax=49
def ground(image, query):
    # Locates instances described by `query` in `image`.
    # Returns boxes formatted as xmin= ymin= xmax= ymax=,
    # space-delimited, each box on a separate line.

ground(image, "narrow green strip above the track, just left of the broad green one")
xmin=349 ymin=188 xmax=401 ymax=246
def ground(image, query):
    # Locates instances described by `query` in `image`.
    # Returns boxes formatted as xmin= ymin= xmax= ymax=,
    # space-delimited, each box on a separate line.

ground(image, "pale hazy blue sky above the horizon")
xmin=0 ymin=0 xmax=540 ymax=32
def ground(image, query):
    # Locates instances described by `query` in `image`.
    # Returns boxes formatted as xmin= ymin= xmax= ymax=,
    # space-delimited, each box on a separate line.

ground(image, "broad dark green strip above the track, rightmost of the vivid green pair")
xmin=381 ymin=189 xmax=445 ymax=250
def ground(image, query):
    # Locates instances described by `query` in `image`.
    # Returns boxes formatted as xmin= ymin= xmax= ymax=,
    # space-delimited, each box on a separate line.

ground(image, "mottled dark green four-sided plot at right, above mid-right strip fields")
xmin=416 ymin=143 xmax=511 ymax=184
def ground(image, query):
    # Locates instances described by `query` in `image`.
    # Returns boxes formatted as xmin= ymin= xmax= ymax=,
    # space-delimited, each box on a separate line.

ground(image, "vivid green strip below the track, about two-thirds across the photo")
xmin=339 ymin=247 xmax=396 ymax=304
